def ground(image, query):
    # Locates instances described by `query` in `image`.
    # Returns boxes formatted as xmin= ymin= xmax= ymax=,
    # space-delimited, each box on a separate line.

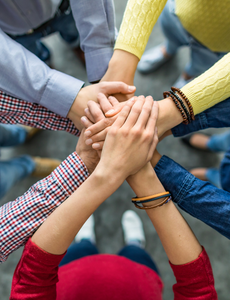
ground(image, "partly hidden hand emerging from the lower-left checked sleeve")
xmin=76 ymin=129 xmax=99 ymax=174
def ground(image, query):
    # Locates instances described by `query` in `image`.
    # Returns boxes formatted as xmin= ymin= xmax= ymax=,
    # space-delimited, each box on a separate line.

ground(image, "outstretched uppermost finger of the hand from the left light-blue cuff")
xmin=100 ymin=81 xmax=136 ymax=95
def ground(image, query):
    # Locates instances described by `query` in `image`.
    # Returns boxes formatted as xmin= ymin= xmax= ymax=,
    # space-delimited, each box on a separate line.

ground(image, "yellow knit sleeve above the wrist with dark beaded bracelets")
xmin=181 ymin=53 xmax=230 ymax=115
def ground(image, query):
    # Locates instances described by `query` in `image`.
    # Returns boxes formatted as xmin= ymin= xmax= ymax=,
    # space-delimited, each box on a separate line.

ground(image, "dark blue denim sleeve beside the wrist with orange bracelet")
xmin=154 ymin=156 xmax=230 ymax=239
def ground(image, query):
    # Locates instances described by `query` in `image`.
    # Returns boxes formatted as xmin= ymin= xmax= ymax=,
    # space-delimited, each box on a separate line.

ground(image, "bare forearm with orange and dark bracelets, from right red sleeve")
xmin=128 ymin=167 xmax=202 ymax=265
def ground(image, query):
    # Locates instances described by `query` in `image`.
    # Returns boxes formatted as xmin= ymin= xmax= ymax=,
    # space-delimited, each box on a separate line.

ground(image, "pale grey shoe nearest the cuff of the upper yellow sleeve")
xmin=137 ymin=44 xmax=173 ymax=74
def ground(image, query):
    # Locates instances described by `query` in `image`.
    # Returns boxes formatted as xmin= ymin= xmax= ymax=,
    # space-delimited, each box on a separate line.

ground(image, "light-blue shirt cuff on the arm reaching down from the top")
xmin=85 ymin=47 xmax=113 ymax=82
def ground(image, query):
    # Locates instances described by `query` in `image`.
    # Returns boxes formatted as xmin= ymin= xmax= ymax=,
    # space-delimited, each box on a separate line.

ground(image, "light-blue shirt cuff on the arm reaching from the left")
xmin=39 ymin=70 xmax=84 ymax=117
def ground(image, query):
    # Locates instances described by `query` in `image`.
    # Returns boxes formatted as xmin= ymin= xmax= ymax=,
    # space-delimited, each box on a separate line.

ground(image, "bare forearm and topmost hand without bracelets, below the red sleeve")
xmin=32 ymin=98 xmax=158 ymax=254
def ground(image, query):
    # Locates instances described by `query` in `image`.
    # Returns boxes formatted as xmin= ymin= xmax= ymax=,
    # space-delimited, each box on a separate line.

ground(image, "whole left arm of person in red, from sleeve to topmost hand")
xmin=11 ymin=97 xmax=157 ymax=299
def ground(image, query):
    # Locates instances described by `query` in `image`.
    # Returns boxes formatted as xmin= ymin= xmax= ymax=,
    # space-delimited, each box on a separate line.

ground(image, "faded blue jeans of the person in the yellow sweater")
xmin=159 ymin=0 xmax=226 ymax=77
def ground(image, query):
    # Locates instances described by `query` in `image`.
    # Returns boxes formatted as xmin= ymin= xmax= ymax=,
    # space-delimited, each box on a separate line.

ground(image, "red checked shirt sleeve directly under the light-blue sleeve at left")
xmin=0 ymin=91 xmax=80 ymax=136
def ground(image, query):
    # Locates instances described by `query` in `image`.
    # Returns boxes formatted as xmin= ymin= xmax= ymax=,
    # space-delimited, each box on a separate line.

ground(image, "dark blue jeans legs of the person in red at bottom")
xmin=59 ymin=239 xmax=160 ymax=276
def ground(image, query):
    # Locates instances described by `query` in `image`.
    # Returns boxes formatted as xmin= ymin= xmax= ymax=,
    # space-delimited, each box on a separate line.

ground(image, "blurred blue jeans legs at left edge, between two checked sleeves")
xmin=0 ymin=124 xmax=35 ymax=199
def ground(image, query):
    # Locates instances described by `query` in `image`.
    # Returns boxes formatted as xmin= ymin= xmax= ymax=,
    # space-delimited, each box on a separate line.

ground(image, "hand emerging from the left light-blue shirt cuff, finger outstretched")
xmin=67 ymin=82 xmax=136 ymax=130
